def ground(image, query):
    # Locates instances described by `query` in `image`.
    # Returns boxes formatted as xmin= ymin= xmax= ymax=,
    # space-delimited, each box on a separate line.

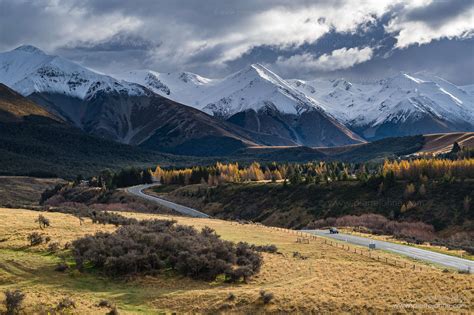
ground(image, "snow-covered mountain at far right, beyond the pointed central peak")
xmin=289 ymin=73 xmax=474 ymax=136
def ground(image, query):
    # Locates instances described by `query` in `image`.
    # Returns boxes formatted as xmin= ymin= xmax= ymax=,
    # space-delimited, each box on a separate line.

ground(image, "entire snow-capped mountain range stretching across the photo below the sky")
xmin=0 ymin=45 xmax=474 ymax=155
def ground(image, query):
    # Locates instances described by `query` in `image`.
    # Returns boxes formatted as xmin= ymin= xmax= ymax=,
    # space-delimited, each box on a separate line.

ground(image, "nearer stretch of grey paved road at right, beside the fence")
xmin=304 ymin=230 xmax=474 ymax=273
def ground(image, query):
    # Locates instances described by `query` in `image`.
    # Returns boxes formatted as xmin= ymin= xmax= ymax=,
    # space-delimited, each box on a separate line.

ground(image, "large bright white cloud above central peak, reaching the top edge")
xmin=200 ymin=0 xmax=393 ymax=63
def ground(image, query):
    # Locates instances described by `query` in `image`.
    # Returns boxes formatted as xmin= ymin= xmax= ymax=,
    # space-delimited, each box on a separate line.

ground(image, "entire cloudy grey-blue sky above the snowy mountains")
xmin=0 ymin=0 xmax=474 ymax=85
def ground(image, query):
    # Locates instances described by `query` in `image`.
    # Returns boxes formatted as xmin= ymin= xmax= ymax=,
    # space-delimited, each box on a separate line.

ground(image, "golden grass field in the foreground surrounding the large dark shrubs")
xmin=0 ymin=208 xmax=474 ymax=314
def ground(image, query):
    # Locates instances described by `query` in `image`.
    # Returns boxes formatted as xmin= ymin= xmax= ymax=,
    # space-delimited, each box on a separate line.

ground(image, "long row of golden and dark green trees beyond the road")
xmin=81 ymin=149 xmax=474 ymax=189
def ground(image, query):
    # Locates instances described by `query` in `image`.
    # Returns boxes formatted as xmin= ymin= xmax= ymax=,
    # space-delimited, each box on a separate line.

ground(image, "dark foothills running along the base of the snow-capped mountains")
xmin=0 ymin=83 xmax=474 ymax=178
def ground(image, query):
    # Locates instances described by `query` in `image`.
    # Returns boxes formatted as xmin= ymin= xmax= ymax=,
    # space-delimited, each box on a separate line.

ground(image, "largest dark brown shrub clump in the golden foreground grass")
xmin=72 ymin=220 xmax=262 ymax=282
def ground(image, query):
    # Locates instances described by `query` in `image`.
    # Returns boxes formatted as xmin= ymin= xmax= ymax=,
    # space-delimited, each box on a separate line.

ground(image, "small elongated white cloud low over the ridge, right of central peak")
xmin=276 ymin=47 xmax=373 ymax=72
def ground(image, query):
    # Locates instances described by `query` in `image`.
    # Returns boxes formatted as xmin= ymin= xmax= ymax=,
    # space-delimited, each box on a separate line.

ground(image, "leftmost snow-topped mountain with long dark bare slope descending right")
xmin=0 ymin=46 xmax=262 ymax=155
